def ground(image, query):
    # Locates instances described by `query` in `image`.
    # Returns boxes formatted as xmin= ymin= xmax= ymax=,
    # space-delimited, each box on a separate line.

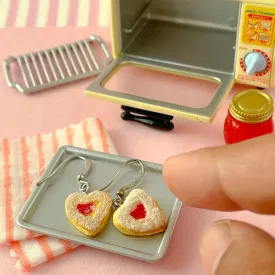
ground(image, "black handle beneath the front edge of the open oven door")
xmin=121 ymin=106 xmax=174 ymax=131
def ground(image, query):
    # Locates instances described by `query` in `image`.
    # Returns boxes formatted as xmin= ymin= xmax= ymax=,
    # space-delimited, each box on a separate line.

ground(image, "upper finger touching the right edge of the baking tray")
xmin=163 ymin=134 xmax=275 ymax=214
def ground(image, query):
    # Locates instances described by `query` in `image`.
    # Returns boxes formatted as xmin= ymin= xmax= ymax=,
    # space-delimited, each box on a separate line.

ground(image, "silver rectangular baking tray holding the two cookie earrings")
xmin=17 ymin=146 xmax=182 ymax=262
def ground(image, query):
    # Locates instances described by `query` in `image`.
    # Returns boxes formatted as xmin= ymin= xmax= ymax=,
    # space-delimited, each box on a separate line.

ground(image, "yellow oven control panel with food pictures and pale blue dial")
xmin=235 ymin=3 xmax=275 ymax=88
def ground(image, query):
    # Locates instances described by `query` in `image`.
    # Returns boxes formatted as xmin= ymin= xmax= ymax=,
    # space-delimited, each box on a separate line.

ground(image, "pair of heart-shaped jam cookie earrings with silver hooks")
xmin=37 ymin=156 xmax=167 ymax=237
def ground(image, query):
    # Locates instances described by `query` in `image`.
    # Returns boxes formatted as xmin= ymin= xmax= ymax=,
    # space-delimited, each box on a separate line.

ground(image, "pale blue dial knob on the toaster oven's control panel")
xmin=245 ymin=52 xmax=268 ymax=75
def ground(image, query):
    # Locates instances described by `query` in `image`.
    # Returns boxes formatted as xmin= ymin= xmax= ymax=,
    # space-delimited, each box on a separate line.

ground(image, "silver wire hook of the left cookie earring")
xmin=36 ymin=156 xmax=92 ymax=194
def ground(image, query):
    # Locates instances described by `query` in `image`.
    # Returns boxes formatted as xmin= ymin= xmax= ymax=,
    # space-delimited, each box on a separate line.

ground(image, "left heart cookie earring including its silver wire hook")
xmin=37 ymin=156 xmax=112 ymax=237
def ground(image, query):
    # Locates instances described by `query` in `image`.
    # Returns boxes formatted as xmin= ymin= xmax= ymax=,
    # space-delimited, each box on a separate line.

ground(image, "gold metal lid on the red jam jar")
xmin=229 ymin=90 xmax=274 ymax=123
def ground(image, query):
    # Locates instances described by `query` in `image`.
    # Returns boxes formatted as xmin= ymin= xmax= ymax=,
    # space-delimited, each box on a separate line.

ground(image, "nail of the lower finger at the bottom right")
xmin=200 ymin=221 xmax=232 ymax=275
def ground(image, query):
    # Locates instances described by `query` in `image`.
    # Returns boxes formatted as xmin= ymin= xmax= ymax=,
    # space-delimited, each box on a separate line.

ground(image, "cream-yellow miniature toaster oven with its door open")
xmin=85 ymin=0 xmax=275 ymax=123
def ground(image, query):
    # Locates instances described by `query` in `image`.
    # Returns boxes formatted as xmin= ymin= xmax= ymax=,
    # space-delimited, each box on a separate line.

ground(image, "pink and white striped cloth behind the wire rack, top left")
xmin=0 ymin=0 xmax=109 ymax=28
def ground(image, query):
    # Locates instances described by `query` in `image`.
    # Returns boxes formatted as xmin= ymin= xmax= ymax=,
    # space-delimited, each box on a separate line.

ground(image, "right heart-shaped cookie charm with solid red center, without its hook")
xmin=113 ymin=189 xmax=167 ymax=236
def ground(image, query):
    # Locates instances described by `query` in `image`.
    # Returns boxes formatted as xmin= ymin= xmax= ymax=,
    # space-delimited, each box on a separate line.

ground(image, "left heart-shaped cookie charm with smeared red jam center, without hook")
xmin=65 ymin=191 xmax=112 ymax=236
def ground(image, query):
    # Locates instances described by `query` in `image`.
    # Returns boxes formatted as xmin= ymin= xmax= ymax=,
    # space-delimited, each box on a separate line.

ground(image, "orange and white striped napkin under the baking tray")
xmin=0 ymin=118 xmax=116 ymax=270
